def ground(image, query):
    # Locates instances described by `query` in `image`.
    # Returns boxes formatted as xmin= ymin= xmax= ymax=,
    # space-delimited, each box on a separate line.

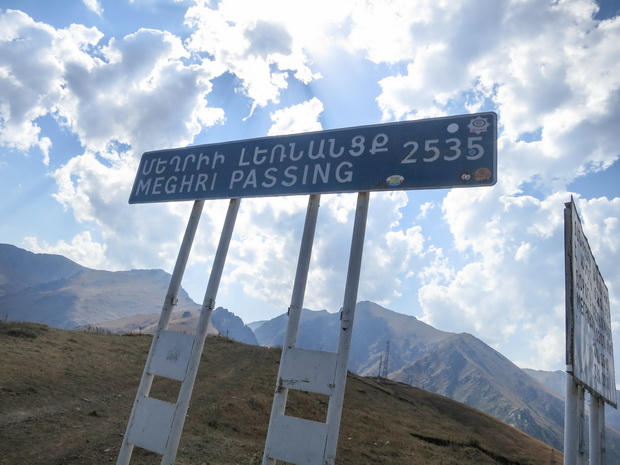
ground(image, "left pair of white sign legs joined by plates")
xmin=116 ymin=199 xmax=239 ymax=465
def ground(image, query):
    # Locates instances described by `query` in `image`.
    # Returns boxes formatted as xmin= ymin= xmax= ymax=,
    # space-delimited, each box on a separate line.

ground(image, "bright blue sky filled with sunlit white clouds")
xmin=0 ymin=0 xmax=620 ymax=379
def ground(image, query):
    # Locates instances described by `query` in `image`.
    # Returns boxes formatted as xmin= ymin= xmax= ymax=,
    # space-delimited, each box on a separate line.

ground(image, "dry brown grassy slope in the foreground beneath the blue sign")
xmin=0 ymin=323 xmax=562 ymax=465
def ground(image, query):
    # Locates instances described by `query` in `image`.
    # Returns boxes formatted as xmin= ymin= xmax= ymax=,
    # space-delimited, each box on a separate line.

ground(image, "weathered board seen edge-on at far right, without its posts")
xmin=565 ymin=201 xmax=617 ymax=407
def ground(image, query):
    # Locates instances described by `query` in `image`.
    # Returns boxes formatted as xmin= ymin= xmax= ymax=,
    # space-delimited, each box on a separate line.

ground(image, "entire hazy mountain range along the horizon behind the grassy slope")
xmin=0 ymin=245 xmax=620 ymax=463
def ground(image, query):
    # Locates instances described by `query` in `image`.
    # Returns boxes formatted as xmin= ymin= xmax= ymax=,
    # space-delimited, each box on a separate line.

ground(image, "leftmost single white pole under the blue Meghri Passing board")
xmin=116 ymin=200 xmax=204 ymax=465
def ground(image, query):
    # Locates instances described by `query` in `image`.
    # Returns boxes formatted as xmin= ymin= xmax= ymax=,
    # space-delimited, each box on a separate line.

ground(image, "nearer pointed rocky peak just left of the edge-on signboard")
xmin=391 ymin=334 xmax=564 ymax=449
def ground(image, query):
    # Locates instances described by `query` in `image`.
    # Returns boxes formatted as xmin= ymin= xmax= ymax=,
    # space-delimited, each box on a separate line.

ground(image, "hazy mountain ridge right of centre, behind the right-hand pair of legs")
xmin=255 ymin=302 xmax=620 ymax=463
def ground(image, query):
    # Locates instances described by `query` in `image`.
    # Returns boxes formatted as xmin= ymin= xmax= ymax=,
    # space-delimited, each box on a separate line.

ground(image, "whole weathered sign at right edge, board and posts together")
xmin=564 ymin=199 xmax=617 ymax=465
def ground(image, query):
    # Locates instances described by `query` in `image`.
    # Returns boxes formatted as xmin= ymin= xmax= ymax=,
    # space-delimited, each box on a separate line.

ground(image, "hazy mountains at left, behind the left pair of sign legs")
xmin=0 ymin=244 xmax=257 ymax=344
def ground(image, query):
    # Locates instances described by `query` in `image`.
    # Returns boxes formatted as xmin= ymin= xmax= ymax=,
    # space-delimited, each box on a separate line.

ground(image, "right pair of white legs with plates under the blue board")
xmin=263 ymin=192 xmax=369 ymax=465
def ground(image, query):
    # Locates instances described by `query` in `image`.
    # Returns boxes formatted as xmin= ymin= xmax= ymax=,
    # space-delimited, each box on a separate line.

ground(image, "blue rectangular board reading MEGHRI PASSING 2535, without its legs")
xmin=129 ymin=112 xmax=497 ymax=203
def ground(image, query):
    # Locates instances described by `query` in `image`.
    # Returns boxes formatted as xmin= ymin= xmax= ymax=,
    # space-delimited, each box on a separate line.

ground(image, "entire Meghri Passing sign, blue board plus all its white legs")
xmin=117 ymin=113 xmax=497 ymax=465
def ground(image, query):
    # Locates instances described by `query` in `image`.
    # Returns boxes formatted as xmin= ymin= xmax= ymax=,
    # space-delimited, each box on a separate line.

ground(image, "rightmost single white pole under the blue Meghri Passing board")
xmin=325 ymin=192 xmax=370 ymax=465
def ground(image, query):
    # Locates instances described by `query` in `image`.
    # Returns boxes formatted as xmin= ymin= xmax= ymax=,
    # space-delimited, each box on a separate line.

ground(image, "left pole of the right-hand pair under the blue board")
xmin=263 ymin=194 xmax=321 ymax=465
